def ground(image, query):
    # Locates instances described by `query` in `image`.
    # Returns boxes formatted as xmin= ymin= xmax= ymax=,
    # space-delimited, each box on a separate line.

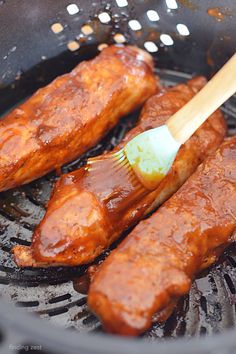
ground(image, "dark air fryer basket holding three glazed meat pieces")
xmin=0 ymin=0 xmax=236 ymax=354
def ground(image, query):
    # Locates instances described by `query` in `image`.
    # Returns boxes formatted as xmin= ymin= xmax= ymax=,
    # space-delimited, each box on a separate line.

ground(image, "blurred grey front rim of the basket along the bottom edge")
xmin=0 ymin=299 xmax=236 ymax=354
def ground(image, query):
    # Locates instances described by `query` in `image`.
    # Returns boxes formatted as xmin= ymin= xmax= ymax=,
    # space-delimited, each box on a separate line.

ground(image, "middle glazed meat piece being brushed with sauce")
xmin=14 ymin=77 xmax=225 ymax=267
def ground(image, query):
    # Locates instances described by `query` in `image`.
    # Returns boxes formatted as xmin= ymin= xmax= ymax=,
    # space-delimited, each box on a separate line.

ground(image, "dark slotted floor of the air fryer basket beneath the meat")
xmin=0 ymin=71 xmax=236 ymax=348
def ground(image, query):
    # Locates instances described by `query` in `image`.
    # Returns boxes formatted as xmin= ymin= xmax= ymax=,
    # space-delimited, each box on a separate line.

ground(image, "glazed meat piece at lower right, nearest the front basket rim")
xmin=88 ymin=136 xmax=236 ymax=335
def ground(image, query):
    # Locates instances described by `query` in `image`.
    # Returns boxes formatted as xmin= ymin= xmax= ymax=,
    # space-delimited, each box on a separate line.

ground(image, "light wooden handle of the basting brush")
xmin=166 ymin=54 xmax=236 ymax=144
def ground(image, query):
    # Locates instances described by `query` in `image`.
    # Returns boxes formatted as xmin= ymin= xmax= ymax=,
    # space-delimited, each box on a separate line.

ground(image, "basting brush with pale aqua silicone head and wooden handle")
xmin=87 ymin=54 xmax=236 ymax=190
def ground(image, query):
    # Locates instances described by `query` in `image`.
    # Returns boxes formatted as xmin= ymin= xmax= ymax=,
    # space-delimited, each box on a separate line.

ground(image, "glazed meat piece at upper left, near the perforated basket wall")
xmin=0 ymin=46 xmax=157 ymax=191
